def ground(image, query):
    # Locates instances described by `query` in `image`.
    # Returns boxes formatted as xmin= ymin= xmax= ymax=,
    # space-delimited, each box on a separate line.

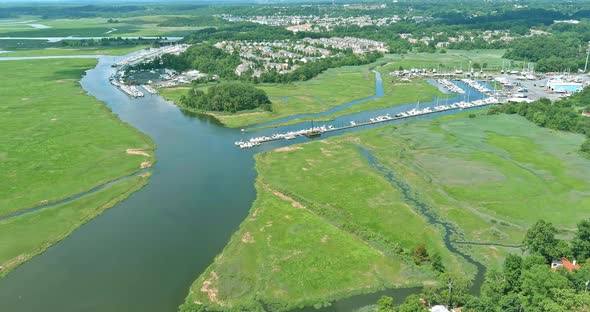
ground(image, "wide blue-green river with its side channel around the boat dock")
xmin=0 ymin=52 xmax=490 ymax=312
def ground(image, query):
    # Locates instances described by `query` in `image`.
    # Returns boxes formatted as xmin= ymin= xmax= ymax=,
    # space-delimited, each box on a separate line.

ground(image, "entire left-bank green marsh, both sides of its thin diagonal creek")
xmin=0 ymin=59 xmax=154 ymax=277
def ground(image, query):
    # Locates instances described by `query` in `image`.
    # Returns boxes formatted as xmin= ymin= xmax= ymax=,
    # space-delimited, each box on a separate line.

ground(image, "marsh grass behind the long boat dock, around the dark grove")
xmin=160 ymin=55 xmax=449 ymax=128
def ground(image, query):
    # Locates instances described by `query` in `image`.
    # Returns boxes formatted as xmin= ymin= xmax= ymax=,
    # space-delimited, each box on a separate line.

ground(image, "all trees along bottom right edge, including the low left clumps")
xmin=377 ymin=220 xmax=590 ymax=312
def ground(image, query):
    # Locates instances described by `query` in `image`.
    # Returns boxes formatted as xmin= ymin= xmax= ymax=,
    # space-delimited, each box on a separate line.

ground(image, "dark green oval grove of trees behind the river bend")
xmin=180 ymin=82 xmax=272 ymax=113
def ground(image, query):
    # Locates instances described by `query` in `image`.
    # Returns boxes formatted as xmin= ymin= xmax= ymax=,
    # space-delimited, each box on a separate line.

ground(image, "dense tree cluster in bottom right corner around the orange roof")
xmin=464 ymin=220 xmax=590 ymax=312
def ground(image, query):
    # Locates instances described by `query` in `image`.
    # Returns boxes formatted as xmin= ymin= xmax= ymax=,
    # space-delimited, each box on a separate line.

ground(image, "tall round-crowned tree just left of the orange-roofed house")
xmin=522 ymin=220 xmax=567 ymax=263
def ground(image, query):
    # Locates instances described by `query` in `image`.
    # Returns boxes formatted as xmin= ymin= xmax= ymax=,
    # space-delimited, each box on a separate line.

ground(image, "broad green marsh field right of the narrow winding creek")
xmin=362 ymin=115 xmax=590 ymax=265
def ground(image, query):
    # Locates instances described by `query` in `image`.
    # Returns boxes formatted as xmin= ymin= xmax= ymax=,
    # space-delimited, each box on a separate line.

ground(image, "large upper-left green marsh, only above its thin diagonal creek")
xmin=0 ymin=59 xmax=154 ymax=216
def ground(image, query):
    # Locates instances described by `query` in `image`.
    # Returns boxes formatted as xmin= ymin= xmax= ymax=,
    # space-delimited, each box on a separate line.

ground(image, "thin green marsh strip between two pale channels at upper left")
xmin=0 ymin=45 xmax=149 ymax=57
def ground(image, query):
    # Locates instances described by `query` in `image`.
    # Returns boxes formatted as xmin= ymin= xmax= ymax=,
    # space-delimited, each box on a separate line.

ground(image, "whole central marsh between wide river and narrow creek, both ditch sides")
xmin=182 ymin=129 xmax=473 ymax=310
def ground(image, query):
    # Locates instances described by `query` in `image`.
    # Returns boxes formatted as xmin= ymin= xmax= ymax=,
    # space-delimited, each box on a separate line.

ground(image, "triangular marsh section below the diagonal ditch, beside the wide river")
xmin=181 ymin=181 xmax=440 ymax=311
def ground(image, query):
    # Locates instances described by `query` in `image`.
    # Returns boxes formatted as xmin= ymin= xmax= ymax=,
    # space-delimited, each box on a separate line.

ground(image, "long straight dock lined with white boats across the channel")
xmin=234 ymin=97 xmax=500 ymax=149
